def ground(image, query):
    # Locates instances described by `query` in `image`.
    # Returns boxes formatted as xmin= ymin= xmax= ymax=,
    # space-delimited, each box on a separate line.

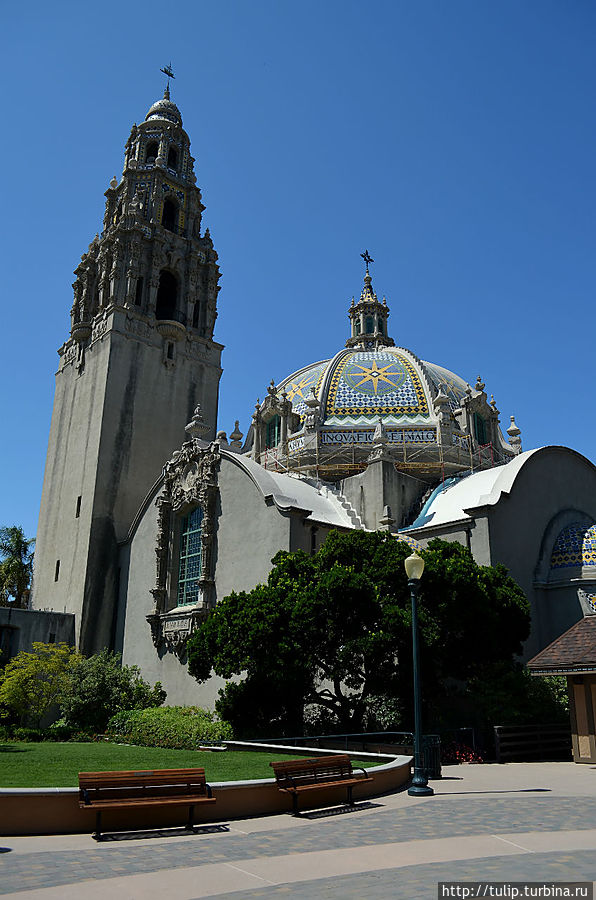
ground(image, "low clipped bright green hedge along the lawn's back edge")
xmin=107 ymin=706 xmax=233 ymax=750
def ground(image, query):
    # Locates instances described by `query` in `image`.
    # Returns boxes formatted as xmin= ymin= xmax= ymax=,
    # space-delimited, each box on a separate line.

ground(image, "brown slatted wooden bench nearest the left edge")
xmin=79 ymin=769 xmax=215 ymax=840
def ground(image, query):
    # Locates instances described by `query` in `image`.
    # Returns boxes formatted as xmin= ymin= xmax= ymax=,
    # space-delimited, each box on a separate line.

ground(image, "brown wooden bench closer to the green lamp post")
xmin=269 ymin=753 xmax=372 ymax=816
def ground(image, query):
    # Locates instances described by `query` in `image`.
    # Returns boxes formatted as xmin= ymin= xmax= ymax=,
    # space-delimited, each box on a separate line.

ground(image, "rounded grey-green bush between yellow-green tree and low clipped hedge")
xmin=59 ymin=650 xmax=166 ymax=732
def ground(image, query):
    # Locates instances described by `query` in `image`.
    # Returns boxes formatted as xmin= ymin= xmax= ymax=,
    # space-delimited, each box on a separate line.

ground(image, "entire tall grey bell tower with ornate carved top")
xmin=33 ymin=88 xmax=223 ymax=652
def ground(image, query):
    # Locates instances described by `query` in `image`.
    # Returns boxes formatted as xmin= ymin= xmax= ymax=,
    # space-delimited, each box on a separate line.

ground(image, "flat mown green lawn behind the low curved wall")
xmin=0 ymin=741 xmax=375 ymax=787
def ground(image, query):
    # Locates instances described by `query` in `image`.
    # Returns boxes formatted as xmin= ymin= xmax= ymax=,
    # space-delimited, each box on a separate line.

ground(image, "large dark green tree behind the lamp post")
xmin=188 ymin=531 xmax=529 ymax=734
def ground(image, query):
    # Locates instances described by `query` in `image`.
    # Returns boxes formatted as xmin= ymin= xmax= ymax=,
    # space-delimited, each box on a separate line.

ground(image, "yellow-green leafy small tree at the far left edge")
xmin=0 ymin=641 xmax=81 ymax=728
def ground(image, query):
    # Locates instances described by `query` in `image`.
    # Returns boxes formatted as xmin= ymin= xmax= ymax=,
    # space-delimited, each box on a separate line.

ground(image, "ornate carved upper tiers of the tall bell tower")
xmin=71 ymin=82 xmax=220 ymax=345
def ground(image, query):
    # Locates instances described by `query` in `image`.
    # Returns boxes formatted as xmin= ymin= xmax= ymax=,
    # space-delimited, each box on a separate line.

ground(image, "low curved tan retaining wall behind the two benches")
xmin=0 ymin=744 xmax=411 ymax=835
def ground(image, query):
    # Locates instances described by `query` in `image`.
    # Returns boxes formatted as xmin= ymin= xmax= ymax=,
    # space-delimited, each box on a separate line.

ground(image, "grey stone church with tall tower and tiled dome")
xmin=33 ymin=89 xmax=596 ymax=705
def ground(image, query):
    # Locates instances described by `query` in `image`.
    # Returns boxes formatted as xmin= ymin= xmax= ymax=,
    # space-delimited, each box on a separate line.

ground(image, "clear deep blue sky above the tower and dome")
xmin=0 ymin=0 xmax=596 ymax=535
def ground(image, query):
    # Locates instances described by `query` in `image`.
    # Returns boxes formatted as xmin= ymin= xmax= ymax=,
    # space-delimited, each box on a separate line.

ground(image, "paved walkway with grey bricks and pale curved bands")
xmin=0 ymin=763 xmax=596 ymax=900
